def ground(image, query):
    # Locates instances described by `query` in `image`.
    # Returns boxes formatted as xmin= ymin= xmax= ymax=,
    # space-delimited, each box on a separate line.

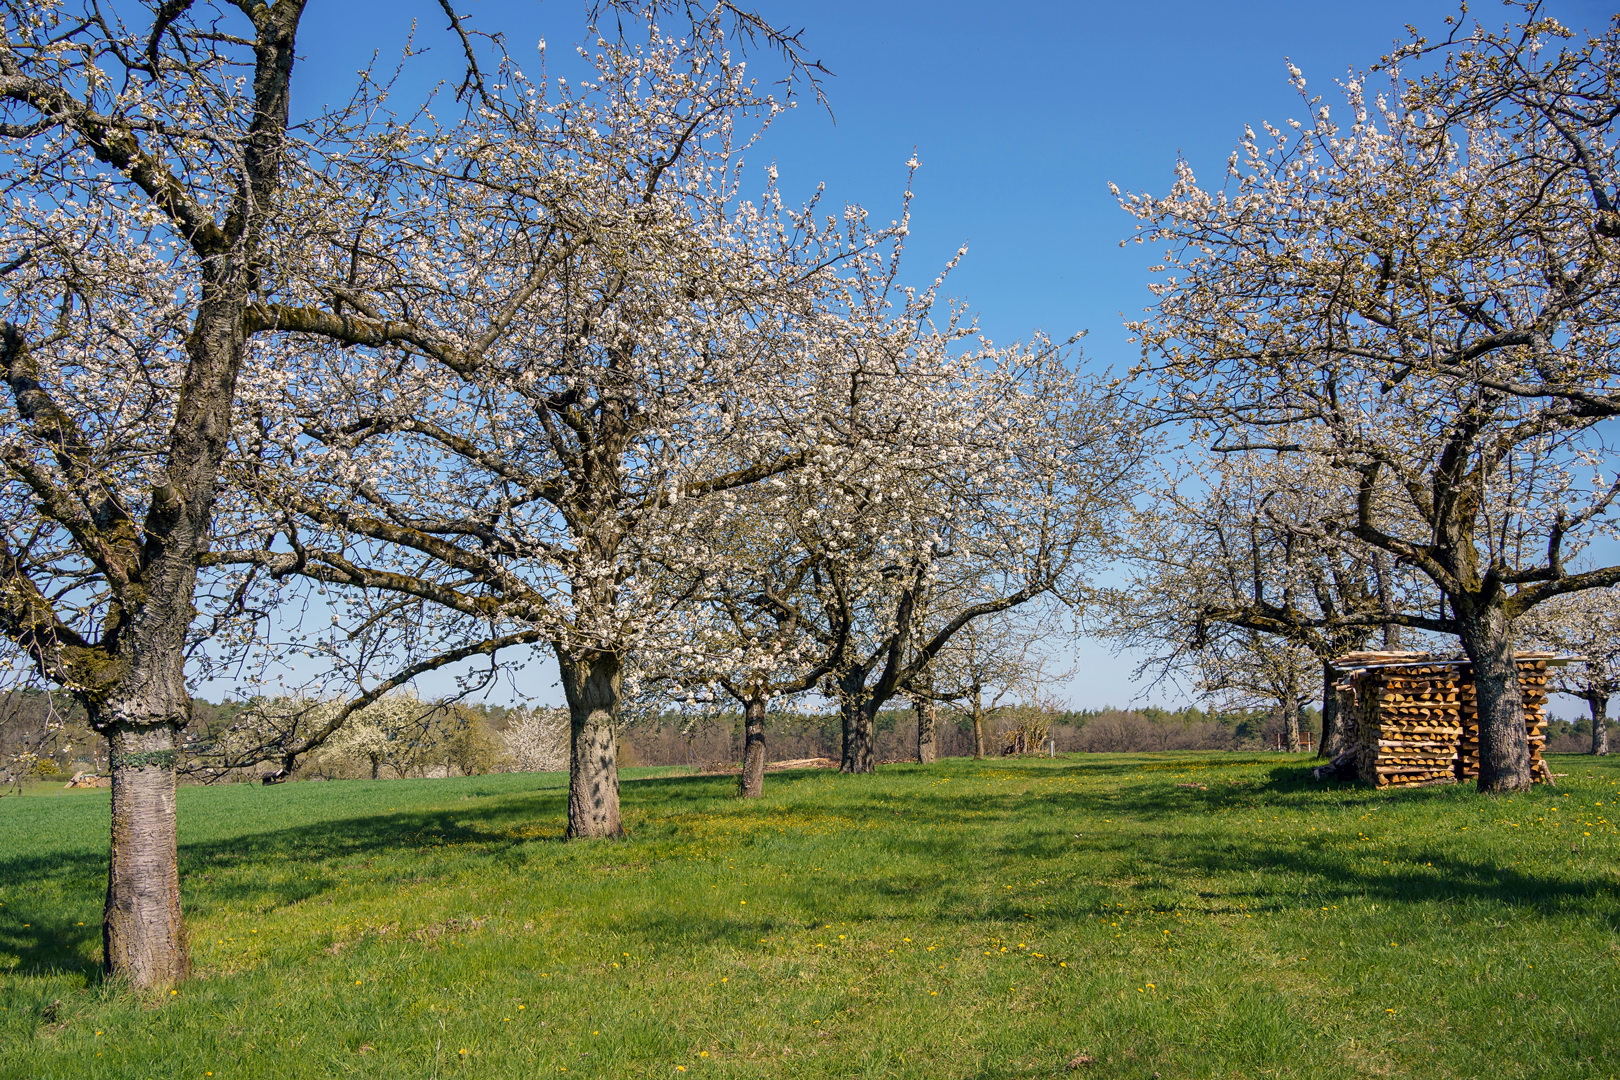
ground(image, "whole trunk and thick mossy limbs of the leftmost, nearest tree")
xmin=0 ymin=0 xmax=320 ymax=989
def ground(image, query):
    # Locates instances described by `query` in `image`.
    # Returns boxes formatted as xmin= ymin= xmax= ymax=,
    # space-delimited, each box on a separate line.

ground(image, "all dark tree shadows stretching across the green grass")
xmin=9 ymin=759 xmax=1617 ymax=978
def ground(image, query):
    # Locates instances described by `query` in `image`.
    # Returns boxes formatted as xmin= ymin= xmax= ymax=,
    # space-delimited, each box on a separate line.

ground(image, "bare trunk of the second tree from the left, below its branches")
xmin=556 ymin=648 xmax=624 ymax=840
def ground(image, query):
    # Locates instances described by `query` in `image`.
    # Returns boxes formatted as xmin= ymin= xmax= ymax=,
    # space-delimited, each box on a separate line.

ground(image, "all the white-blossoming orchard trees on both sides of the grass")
xmin=0 ymin=0 xmax=1620 ymax=988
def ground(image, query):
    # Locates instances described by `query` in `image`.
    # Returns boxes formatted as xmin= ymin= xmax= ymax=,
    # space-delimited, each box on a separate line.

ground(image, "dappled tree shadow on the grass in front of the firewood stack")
xmin=835 ymin=764 xmax=1620 ymax=920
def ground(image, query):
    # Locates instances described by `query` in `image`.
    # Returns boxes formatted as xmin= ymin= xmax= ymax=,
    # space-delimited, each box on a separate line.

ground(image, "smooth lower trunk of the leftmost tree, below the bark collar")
xmin=102 ymin=721 xmax=191 ymax=989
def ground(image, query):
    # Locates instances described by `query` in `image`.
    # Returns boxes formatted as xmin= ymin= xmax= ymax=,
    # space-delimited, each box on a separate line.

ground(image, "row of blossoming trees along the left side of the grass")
xmin=0 ymin=0 xmax=1140 ymax=988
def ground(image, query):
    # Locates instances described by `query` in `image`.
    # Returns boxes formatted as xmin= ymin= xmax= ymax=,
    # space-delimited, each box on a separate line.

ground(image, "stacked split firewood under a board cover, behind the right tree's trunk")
xmin=1333 ymin=653 xmax=1570 ymax=787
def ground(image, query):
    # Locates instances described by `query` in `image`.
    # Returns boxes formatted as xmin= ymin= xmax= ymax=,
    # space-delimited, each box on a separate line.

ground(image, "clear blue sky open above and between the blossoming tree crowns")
xmin=272 ymin=0 xmax=1612 ymax=718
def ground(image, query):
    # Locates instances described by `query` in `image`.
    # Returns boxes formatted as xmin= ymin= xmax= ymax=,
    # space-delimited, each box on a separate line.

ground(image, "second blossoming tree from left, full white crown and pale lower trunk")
xmin=211 ymin=28 xmax=926 ymax=837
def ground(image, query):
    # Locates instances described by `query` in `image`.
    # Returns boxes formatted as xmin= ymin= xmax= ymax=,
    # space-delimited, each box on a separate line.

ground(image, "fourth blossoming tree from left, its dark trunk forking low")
xmin=794 ymin=338 xmax=1144 ymax=772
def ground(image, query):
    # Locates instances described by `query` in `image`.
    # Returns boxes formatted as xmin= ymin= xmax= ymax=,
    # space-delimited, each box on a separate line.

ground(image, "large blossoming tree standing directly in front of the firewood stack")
xmin=1124 ymin=5 xmax=1620 ymax=792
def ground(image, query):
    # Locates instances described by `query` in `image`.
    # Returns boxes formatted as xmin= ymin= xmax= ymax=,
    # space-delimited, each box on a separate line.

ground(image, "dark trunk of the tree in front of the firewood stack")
xmin=1453 ymin=601 xmax=1534 ymax=793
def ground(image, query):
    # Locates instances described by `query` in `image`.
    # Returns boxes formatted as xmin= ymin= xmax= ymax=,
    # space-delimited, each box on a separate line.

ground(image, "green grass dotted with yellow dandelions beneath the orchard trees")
xmin=0 ymin=753 xmax=1620 ymax=1080
